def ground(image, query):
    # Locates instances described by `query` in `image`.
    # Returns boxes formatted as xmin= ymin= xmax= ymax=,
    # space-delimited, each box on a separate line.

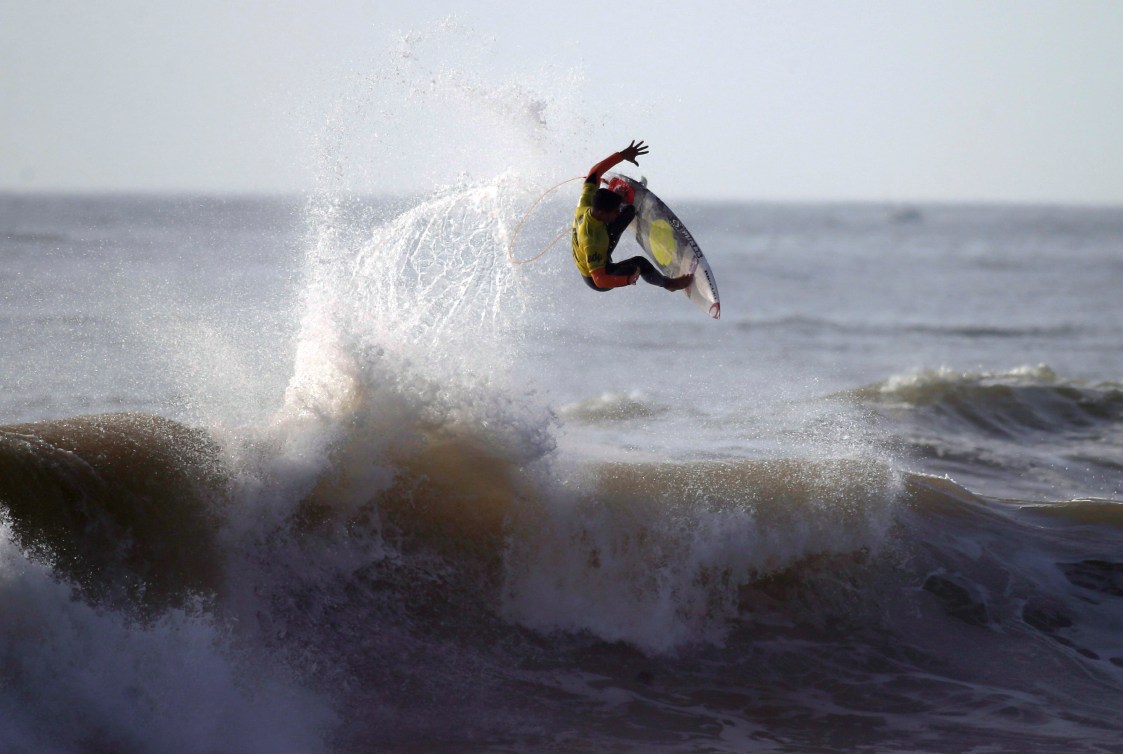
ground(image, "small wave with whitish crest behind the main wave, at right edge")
xmin=849 ymin=364 xmax=1123 ymax=498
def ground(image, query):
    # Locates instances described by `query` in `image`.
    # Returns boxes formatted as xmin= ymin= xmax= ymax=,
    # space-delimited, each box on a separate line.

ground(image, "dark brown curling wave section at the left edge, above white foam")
xmin=0 ymin=414 xmax=225 ymax=601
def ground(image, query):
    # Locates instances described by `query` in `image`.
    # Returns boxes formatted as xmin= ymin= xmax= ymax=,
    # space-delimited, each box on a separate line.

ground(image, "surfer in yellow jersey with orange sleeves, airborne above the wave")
xmin=573 ymin=142 xmax=694 ymax=291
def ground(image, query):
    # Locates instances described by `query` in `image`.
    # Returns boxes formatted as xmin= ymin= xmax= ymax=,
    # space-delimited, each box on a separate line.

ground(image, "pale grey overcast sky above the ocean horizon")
xmin=0 ymin=0 xmax=1123 ymax=205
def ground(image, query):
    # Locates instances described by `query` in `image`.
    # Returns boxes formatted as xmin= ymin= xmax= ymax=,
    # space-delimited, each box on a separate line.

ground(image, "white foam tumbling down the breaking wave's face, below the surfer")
xmin=504 ymin=463 xmax=900 ymax=653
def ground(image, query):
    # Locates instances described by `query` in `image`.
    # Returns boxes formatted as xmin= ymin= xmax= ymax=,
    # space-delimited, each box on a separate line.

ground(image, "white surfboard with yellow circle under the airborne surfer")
xmin=609 ymin=173 xmax=721 ymax=319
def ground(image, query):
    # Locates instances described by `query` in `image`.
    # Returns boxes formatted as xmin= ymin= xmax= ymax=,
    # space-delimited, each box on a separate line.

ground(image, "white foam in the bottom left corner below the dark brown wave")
xmin=0 ymin=527 xmax=334 ymax=754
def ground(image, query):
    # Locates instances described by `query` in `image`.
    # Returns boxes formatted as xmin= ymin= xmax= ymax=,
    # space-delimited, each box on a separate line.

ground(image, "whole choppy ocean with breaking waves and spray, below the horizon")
xmin=0 ymin=189 xmax=1123 ymax=754
